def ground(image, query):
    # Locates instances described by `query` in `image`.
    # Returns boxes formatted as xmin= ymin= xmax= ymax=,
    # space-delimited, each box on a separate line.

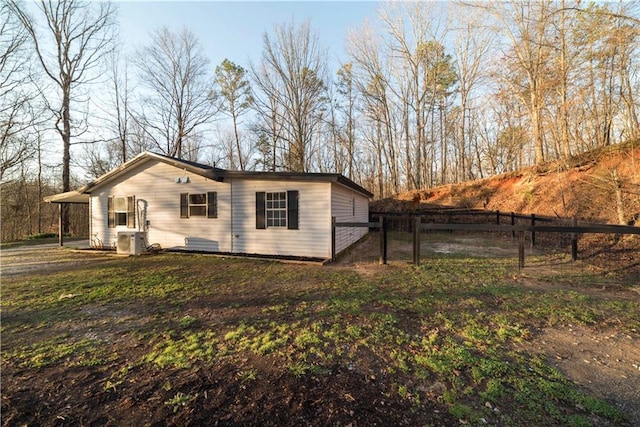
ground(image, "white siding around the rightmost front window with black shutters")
xmin=231 ymin=179 xmax=331 ymax=258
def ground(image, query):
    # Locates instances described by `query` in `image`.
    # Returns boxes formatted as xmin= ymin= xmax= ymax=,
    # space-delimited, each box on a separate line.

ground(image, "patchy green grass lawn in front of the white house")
xmin=2 ymin=254 xmax=640 ymax=426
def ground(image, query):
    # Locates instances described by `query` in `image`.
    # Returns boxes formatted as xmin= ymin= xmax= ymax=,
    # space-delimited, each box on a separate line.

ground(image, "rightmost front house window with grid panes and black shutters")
xmin=256 ymin=190 xmax=298 ymax=230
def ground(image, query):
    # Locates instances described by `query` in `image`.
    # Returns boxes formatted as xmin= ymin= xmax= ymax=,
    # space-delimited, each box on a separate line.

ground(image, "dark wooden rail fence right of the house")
xmin=331 ymin=210 xmax=640 ymax=269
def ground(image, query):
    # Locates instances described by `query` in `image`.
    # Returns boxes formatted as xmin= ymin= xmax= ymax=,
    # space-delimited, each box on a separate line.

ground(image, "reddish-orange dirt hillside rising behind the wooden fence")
xmin=370 ymin=143 xmax=640 ymax=225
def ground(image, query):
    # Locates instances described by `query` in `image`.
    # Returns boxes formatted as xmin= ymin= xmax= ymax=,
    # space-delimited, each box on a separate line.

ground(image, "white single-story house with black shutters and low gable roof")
xmin=45 ymin=152 xmax=372 ymax=259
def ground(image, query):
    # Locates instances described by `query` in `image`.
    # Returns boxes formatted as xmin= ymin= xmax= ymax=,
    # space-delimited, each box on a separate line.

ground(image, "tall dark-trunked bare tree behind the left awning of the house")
xmin=7 ymin=0 xmax=116 ymax=232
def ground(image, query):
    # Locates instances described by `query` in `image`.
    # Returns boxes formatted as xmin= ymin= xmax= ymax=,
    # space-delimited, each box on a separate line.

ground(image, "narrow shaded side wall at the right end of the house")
xmin=331 ymin=184 xmax=369 ymax=254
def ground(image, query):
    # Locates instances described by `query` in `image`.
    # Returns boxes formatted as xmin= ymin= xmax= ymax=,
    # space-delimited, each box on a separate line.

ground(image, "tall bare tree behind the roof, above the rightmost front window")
xmin=252 ymin=21 xmax=326 ymax=171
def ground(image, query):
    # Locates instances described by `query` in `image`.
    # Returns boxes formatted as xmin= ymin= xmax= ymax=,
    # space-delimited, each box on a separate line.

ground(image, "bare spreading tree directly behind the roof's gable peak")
xmin=134 ymin=27 xmax=217 ymax=157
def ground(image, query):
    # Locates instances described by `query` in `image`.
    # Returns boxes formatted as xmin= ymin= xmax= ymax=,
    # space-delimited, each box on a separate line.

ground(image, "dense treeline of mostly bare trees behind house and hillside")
xmin=0 ymin=0 xmax=640 ymax=240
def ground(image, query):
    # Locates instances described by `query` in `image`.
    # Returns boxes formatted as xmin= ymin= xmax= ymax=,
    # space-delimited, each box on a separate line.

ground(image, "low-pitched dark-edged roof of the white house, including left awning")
xmin=45 ymin=151 xmax=373 ymax=203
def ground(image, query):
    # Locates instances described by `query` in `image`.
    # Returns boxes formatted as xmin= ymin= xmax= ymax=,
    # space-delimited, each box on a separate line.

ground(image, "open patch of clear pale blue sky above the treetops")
xmin=117 ymin=1 xmax=380 ymax=69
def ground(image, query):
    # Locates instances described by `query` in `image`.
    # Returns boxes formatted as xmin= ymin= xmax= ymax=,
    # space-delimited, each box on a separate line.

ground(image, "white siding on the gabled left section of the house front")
xmin=90 ymin=160 xmax=231 ymax=252
